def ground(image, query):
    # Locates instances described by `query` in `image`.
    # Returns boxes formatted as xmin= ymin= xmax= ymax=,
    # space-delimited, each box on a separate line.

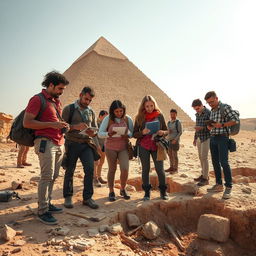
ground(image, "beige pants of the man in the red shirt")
xmin=35 ymin=138 xmax=64 ymax=214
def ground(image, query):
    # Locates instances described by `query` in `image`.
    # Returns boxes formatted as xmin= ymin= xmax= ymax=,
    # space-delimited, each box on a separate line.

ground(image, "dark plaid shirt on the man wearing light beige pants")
xmin=194 ymin=107 xmax=211 ymax=142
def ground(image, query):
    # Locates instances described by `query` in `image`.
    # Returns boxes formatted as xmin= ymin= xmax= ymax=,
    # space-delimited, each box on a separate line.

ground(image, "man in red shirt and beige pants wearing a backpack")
xmin=23 ymin=71 xmax=69 ymax=225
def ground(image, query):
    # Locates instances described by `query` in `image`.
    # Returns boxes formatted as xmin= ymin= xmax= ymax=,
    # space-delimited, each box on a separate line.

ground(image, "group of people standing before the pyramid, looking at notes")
xmin=23 ymin=72 xmax=240 ymax=225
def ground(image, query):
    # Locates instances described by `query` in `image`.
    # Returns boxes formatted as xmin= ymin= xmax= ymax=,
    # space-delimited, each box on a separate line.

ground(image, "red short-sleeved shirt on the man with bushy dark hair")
xmin=26 ymin=89 xmax=64 ymax=145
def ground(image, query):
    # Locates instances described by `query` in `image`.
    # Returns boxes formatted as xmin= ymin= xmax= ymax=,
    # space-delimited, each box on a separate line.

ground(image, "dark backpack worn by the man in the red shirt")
xmin=9 ymin=93 xmax=46 ymax=147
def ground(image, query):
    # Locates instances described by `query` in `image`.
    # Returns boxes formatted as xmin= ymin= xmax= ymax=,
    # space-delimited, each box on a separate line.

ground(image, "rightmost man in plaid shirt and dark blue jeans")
xmin=204 ymin=91 xmax=239 ymax=199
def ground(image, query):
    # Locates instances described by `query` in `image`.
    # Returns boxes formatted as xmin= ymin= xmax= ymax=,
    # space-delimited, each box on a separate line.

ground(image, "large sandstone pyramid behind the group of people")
xmin=61 ymin=37 xmax=193 ymax=128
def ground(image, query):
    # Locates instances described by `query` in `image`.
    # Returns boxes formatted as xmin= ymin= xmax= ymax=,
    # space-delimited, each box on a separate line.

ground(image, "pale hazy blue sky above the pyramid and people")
xmin=0 ymin=0 xmax=256 ymax=118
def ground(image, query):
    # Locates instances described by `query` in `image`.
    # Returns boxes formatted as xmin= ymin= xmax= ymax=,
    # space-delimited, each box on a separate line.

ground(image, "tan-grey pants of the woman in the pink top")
xmin=106 ymin=149 xmax=129 ymax=189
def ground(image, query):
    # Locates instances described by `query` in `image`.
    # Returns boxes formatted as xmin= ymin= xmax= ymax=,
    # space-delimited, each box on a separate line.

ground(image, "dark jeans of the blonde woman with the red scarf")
xmin=139 ymin=146 xmax=166 ymax=186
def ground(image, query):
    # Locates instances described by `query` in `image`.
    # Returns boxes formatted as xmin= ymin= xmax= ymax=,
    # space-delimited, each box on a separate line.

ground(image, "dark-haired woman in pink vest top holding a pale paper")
xmin=98 ymin=100 xmax=133 ymax=201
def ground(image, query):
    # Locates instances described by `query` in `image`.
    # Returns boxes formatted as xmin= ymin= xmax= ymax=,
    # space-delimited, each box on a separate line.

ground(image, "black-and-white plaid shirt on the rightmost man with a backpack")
xmin=210 ymin=101 xmax=239 ymax=135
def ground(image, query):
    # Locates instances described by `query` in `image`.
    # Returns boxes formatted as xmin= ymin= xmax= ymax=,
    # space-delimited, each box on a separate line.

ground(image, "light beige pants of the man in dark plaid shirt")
xmin=196 ymin=138 xmax=210 ymax=179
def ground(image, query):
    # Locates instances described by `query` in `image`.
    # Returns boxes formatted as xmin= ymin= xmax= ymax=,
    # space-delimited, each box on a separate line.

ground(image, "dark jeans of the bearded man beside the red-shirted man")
xmin=63 ymin=142 xmax=94 ymax=200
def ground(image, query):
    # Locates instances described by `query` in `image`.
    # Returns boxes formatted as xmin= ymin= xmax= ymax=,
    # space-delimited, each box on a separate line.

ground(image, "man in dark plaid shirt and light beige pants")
xmin=192 ymin=99 xmax=211 ymax=186
